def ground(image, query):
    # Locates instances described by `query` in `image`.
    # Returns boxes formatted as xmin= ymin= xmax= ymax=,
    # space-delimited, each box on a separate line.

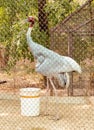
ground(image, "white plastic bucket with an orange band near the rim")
xmin=20 ymin=88 xmax=40 ymax=116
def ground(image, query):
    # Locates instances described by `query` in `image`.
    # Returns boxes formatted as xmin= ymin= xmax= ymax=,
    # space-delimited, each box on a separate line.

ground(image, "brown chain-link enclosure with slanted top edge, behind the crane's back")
xmin=51 ymin=1 xmax=94 ymax=95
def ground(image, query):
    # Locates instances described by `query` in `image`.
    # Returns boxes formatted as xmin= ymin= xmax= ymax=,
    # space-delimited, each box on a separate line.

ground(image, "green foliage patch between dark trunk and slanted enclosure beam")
xmin=45 ymin=0 xmax=78 ymax=27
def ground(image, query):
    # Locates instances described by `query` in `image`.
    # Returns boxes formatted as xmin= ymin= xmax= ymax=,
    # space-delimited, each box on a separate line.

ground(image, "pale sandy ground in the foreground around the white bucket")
xmin=0 ymin=97 xmax=94 ymax=130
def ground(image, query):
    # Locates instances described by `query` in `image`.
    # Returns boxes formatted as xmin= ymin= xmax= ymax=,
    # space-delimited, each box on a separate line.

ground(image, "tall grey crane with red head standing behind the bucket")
xmin=27 ymin=16 xmax=81 ymax=120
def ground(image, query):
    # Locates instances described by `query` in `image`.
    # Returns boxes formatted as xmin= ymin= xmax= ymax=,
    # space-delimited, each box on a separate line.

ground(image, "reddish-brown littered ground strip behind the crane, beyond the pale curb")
xmin=0 ymin=69 xmax=94 ymax=96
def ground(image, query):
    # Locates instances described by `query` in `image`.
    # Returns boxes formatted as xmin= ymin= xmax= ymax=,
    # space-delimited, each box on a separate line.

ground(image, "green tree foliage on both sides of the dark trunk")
xmin=0 ymin=0 xmax=77 ymax=70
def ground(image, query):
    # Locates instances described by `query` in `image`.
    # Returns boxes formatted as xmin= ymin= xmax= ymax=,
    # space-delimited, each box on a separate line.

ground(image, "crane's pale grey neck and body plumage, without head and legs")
xmin=27 ymin=27 xmax=81 ymax=77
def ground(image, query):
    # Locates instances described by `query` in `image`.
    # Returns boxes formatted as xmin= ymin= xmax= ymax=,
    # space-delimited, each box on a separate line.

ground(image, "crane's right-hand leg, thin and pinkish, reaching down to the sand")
xmin=49 ymin=79 xmax=60 ymax=120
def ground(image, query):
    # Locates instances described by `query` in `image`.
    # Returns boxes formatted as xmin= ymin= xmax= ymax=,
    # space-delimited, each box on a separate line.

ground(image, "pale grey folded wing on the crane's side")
xmin=36 ymin=53 xmax=81 ymax=77
